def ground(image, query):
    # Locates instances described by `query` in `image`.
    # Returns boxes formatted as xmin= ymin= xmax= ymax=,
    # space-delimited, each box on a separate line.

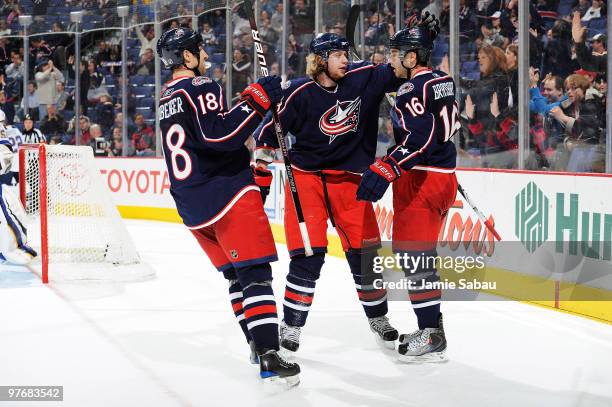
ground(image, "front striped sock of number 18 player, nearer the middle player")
xmin=242 ymin=281 xmax=279 ymax=351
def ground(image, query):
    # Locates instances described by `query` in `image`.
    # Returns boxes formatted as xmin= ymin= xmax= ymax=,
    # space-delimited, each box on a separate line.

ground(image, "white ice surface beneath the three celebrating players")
xmin=0 ymin=221 xmax=612 ymax=407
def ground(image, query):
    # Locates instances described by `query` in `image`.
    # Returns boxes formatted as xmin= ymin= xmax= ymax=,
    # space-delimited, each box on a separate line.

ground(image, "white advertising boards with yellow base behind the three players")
xmin=91 ymin=158 xmax=612 ymax=322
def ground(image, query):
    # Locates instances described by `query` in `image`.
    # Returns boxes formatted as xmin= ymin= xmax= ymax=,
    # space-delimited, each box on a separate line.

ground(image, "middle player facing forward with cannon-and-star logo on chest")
xmin=255 ymin=22 xmax=440 ymax=351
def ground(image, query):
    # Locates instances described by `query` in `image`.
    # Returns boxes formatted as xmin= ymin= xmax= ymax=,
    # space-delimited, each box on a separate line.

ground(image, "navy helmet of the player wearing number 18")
xmin=157 ymin=28 xmax=202 ymax=69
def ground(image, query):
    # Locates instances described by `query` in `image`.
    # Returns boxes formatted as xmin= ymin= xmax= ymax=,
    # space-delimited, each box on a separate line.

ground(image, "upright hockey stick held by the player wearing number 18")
xmin=243 ymin=0 xmax=313 ymax=256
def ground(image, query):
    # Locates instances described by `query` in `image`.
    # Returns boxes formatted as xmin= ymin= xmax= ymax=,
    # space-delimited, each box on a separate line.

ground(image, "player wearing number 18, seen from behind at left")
xmin=157 ymin=28 xmax=300 ymax=385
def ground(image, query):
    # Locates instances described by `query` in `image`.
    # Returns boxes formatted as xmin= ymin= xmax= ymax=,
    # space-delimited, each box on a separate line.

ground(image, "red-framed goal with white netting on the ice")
xmin=19 ymin=144 xmax=154 ymax=283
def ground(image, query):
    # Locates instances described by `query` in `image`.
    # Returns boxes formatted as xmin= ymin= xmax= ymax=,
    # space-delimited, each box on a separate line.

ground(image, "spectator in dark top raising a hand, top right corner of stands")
xmin=572 ymin=11 xmax=608 ymax=73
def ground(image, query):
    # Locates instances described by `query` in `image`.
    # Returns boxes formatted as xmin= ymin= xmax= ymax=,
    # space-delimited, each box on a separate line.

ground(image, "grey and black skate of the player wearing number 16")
xmin=397 ymin=314 xmax=446 ymax=363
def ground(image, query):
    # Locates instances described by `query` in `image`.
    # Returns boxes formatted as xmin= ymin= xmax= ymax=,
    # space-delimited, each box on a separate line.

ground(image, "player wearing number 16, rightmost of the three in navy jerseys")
xmin=357 ymin=27 xmax=460 ymax=362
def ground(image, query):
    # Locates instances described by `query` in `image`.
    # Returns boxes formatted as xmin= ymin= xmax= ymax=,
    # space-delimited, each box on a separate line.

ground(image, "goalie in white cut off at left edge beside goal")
xmin=0 ymin=110 xmax=37 ymax=265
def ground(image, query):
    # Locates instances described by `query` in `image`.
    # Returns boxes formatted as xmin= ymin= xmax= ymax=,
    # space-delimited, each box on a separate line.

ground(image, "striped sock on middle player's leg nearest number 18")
xmin=283 ymin=274 xmax=316 ymax=327
